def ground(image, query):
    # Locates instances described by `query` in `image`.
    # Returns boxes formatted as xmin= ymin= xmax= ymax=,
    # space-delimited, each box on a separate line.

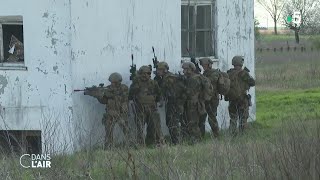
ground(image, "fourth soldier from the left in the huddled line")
xmin=181 ymin=62 xmax=212 ymax=143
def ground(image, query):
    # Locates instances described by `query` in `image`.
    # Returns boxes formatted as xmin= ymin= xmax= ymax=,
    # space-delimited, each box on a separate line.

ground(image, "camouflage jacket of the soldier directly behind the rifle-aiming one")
xmin=129 ymin=76 xmax=161 ymax=105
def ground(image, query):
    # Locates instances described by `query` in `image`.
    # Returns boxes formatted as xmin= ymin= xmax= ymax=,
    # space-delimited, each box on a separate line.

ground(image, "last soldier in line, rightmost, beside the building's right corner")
xmin=225 ymin=56 xmax=255 ymax=134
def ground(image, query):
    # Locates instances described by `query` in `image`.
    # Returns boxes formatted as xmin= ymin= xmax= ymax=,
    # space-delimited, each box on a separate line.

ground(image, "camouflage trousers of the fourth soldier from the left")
xmin=181 ymin=101 xmax=201 ymax=143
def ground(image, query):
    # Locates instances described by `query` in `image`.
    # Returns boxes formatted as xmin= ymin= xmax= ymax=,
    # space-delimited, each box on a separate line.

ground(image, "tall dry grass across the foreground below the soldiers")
xmin=0 ymin=120 xmax=320 ymax=179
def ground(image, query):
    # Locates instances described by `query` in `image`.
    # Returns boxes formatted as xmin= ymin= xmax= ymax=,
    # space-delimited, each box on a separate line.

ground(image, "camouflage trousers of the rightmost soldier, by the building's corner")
xmin=229 ymin=96 xmax=249 ymax=134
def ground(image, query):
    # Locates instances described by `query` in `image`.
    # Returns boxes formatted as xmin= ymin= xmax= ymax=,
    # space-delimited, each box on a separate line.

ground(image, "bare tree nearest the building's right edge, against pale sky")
xmin=257 ymin=0 xmax=285 ymax=35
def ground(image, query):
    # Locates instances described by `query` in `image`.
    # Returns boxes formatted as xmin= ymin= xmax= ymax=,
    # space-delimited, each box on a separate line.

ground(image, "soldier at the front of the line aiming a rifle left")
xmin=84 ymin=73 xmax=129 ymax=148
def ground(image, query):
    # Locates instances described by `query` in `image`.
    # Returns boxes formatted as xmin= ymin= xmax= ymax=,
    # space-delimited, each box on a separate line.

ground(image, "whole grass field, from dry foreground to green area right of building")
xmin=0 ymin=34 xmax=320 ymax=179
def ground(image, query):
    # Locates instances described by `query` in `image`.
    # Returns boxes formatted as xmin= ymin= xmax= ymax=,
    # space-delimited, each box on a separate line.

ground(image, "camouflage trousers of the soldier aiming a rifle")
xmin=102 ymin=113 xmax=129 ymax=148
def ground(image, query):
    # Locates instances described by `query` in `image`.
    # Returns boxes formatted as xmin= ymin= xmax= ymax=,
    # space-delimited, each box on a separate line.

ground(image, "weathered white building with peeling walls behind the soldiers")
xmin=0 ymin=0 xmax=255 ymax=153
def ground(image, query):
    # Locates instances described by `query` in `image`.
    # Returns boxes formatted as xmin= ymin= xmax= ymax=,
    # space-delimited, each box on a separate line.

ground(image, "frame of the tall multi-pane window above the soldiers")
xmin=181 ymin=0 xmax=218 ymax=62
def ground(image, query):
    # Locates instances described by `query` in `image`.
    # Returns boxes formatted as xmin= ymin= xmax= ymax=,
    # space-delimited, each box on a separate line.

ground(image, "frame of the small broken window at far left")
xmin=0 ymin=15 xmax=27 ymax=70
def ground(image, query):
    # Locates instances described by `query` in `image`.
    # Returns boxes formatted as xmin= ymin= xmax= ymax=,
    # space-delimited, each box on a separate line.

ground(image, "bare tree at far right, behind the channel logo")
xmin=283 ymin=0 xmax=320 ymax=44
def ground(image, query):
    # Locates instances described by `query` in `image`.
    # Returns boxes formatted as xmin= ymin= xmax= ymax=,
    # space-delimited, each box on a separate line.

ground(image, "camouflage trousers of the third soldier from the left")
xmin=166 ymin=102 xmax=183 ymax=144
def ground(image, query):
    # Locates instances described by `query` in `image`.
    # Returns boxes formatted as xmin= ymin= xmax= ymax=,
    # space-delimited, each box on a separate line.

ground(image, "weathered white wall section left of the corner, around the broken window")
xmin=0 ymin=0 xmax=72 ymax=153
